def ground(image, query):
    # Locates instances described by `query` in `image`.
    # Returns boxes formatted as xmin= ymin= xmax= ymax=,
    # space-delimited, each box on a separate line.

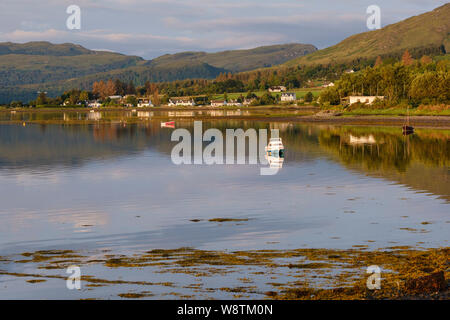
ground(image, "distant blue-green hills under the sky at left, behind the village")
xmin=0 ymin=41 xmax=317 ymax=103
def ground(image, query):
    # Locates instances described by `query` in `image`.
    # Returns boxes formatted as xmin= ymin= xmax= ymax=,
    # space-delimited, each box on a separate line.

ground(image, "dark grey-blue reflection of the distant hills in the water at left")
xmin=0 ymin=124 xmax=170 ymax=168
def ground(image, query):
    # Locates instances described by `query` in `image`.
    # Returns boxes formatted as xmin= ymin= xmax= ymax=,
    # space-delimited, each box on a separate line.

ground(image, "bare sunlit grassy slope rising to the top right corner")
xmin=285 ymin=3 xmax=450 ymax=66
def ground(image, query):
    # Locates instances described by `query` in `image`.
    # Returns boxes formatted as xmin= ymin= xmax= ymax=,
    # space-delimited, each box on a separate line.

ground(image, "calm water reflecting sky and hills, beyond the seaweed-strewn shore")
xmin=0 ymin=114 xmax=450 ymax=297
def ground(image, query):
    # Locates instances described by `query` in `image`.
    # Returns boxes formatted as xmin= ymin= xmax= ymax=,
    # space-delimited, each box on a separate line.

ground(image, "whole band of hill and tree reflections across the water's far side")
xmin=0 ymin=120 xmax=450 ymax=201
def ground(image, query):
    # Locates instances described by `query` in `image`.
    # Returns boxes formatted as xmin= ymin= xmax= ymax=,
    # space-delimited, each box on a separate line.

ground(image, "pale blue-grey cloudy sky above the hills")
xmin=0 ymin=0 xmax=447 ymax=59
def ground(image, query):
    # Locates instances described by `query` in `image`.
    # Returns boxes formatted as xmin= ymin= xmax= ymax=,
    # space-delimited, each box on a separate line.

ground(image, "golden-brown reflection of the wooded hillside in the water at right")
xmin=319 ymin=128 xmax=450 ymax=201
